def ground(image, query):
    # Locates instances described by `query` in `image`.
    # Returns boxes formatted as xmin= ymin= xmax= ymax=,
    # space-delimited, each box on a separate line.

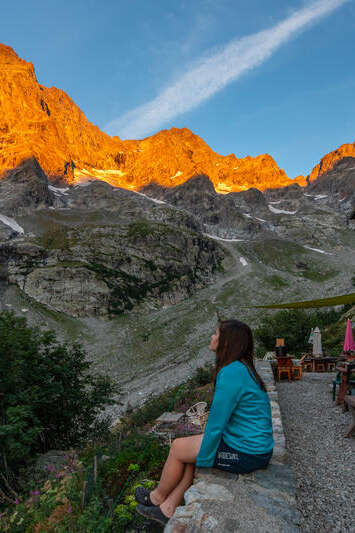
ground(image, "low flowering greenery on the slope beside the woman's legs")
xmin=0 ymin=350 xmax=212 ymax=533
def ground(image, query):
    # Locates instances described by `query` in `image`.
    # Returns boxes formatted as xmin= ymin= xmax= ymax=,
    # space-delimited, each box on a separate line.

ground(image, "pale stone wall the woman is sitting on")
xmin=164 ymin=361 xmax=300 ymax=533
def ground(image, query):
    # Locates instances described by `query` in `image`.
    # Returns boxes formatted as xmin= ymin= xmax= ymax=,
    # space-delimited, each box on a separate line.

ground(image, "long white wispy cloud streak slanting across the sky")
xmin=105 ymin=0 xmax=348 ymax=139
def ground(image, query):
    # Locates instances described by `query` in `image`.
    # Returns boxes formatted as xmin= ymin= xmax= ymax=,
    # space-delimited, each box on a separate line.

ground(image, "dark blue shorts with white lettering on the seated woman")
xmin=213 ymin=439 xmax=272 ymax=474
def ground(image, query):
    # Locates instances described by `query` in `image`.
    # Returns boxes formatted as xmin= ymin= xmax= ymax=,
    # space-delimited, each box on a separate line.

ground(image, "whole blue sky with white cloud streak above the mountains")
xmin=0 ymin=0 xmax=355 ymax=177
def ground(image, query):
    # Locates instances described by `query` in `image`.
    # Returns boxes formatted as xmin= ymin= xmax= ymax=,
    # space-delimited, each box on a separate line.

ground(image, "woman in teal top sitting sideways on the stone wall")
xmin=135 ymin=320 xmax=274 ymax=524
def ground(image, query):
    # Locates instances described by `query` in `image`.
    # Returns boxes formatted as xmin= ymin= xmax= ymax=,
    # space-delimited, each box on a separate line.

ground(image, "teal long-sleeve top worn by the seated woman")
xmin=196 ymin=361 xmax=274 ymax=467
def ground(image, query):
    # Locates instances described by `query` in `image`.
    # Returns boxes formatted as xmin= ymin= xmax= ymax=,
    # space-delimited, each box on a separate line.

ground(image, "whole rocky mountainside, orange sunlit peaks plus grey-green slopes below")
xmin=0 ymin=45 xmax=355 ymax=418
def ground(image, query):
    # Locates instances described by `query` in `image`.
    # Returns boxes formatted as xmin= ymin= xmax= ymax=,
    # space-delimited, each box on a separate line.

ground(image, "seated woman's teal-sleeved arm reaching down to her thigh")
xmin=196 ymin=366 xmax=242 ymax=467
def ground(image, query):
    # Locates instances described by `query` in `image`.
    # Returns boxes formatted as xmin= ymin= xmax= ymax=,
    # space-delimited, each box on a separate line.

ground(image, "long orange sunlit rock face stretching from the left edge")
xmin=0 ymin=44 xmax=330 ymax=193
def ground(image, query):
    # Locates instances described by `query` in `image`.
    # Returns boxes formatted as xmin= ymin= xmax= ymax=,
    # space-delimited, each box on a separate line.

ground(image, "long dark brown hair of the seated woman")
xmin=214 ymin=320 xmax=266 ymax=392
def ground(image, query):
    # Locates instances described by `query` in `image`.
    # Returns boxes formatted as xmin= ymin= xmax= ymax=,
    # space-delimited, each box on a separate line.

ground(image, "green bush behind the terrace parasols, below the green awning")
xmin=255 ymin=309 xmax=344 ymax=354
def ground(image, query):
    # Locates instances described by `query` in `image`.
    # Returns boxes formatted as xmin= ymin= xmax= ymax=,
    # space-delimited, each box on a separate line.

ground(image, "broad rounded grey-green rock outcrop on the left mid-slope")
xmin=0 ymin=220 xmax=224 ymax=316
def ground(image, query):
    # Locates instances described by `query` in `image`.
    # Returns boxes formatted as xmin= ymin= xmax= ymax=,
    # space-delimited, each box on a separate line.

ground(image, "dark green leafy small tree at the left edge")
xmin=0 ymin=312 xmax=117 ymax=472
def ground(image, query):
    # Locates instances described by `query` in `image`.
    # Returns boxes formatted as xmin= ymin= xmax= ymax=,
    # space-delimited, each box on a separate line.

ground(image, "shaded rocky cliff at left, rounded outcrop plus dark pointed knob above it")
xmin=0 ymin=158 xmax=225 ymax=316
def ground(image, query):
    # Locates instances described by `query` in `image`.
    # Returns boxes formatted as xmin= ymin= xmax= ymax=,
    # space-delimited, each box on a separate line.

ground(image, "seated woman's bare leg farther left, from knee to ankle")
xmin=150 ymin=434 xmax=203 ymax=505
